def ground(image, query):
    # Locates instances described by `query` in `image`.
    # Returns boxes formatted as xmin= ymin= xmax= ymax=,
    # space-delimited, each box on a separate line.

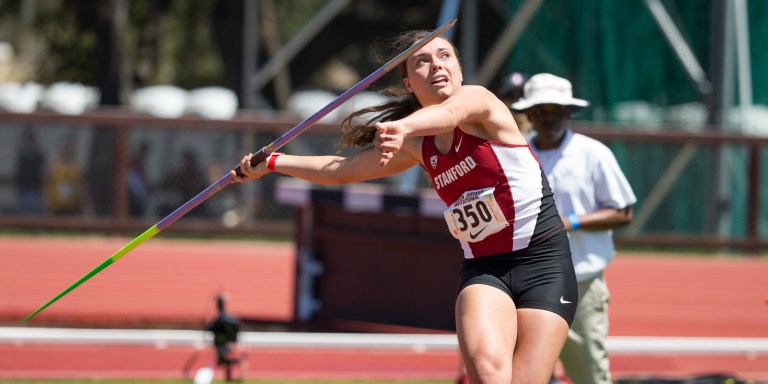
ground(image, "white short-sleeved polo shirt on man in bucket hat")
xmin=529 ymin=129 xmax=637 ymax=282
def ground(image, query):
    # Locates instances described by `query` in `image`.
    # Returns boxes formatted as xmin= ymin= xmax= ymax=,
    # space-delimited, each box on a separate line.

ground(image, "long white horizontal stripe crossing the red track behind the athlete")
xmin=0 ymin=327 xmax=768 ymax=356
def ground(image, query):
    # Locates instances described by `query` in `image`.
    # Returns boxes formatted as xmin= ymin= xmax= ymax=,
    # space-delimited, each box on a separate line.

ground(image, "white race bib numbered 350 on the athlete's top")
xmin=444 ymin=187 xmax=509 ymax=243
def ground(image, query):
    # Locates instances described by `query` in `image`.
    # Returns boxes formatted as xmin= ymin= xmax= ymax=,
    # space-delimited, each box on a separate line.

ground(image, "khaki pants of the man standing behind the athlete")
xmin=560 ymin=274 xmax=611 ymax=384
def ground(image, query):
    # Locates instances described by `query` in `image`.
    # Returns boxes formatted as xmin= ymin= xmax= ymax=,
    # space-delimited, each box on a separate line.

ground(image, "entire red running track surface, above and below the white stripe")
xmin=0 ymin=237 xmax=768 ymax=381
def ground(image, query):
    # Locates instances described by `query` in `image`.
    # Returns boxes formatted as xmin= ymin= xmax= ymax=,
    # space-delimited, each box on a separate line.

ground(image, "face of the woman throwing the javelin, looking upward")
xmin=403 ymin=38 xmax=463 ymax=106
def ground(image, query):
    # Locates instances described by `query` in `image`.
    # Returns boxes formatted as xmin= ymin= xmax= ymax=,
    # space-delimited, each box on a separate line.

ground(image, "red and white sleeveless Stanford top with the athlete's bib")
xmin=421 ymin=128 xmax=563 ymax=259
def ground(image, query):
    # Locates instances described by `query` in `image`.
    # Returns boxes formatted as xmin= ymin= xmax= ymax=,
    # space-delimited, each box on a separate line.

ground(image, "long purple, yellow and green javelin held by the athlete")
xmin=19 ymin=19 xmax=456 ymax=324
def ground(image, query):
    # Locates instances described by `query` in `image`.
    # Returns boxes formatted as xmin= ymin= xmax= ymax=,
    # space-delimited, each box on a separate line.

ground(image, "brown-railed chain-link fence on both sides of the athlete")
xmin=0 ymin=111 xmax=768 ymax=250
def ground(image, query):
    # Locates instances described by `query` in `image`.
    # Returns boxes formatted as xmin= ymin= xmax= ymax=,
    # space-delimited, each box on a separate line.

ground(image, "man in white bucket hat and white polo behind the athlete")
xmin=512 ymin=73 xmax=637 ymax=384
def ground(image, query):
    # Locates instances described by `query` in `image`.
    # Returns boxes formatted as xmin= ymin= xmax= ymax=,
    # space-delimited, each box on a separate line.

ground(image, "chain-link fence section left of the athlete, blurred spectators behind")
xmin=0 ymin=112 xmax=426 ymax=234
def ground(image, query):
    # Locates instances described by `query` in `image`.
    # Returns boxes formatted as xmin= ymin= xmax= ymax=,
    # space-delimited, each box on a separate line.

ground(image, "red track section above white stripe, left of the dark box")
xmin=0 ymin=237 xmax=295 ymax=329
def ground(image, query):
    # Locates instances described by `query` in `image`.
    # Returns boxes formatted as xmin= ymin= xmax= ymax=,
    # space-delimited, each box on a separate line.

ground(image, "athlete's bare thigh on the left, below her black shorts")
xmin=456 ymin=284 xmax=517 ymax=369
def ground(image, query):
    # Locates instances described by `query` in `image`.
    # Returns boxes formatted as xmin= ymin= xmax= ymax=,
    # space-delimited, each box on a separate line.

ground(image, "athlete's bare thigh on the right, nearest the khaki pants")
xmin=512 ymin=308 xmax=568 ymax=383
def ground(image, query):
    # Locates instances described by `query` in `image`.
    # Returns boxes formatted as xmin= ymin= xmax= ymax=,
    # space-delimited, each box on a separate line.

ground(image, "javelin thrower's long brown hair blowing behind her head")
xmin=339 ymin=30 xmax=459 ymax=147
